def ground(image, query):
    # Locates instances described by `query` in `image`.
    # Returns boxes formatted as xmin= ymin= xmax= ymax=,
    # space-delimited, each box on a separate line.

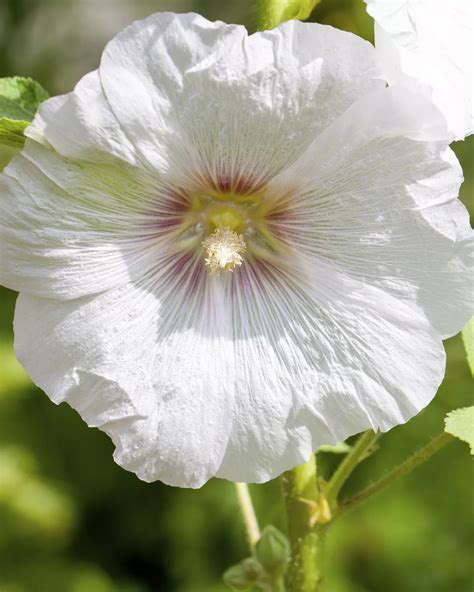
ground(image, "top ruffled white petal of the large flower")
xmin=100 ymin=13 xmax=385 ymax=185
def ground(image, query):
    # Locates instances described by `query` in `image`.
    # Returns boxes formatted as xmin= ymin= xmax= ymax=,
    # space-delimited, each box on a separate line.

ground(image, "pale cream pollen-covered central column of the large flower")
xmin=202 ymin=226 xmax=247 ymax=275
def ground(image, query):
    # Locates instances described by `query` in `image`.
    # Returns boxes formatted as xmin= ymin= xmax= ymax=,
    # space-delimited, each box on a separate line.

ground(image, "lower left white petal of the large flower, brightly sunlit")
xmin=15 ymin=262 xmax=234 ymax=487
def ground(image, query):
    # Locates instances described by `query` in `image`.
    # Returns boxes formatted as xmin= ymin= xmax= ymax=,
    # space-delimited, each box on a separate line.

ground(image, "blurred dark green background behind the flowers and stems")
xmin=0 ymin=0 xmax=474 ymax=592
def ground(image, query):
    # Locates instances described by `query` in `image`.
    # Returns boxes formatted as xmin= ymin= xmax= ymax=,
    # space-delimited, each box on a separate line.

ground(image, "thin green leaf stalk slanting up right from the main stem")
xmin=338 ymin=432 xmax=454 ymax=515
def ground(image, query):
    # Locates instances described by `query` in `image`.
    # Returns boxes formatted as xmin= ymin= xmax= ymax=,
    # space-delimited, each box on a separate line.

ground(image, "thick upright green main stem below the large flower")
xmin=282 ymin=455 xmax=326 ymax=592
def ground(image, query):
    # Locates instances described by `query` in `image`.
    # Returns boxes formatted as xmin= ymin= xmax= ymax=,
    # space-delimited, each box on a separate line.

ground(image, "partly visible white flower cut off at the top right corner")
xmin=365 ymin=0 xmax=474 ymax=140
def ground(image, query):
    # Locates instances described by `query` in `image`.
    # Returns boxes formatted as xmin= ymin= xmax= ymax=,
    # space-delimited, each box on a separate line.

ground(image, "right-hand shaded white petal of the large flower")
xmin=268 ymin=88 xmax=474 ymax=337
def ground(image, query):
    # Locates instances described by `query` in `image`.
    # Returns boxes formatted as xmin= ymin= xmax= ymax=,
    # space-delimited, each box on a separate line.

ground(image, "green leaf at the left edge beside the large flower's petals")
xmin=0 ymin=76 xmax=48 ymax=148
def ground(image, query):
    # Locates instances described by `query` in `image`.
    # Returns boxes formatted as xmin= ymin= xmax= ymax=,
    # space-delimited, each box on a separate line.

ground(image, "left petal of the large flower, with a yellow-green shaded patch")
xmin=0 ymin=140 xmax=183 ymax=298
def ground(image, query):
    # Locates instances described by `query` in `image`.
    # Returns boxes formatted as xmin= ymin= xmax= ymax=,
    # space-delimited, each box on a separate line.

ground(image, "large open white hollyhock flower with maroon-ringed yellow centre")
xmin=0 ymin=14 xmax=472 ymax=487
